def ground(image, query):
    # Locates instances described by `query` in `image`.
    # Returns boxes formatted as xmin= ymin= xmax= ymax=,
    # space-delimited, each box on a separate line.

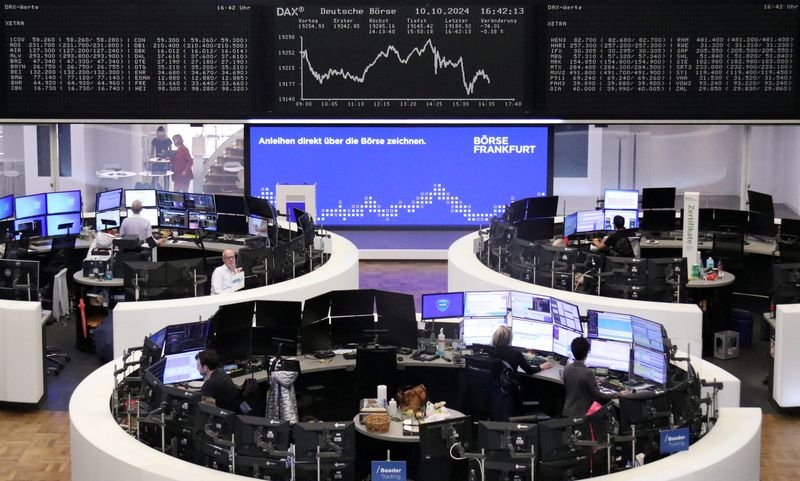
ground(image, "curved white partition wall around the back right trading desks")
xmin=447 ymin=233 xmax=703 ymax=354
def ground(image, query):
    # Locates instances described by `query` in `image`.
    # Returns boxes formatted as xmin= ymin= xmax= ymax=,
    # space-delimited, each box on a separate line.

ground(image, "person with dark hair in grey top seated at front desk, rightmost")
xmin=561 ymin=336 xmax=628 ymax=417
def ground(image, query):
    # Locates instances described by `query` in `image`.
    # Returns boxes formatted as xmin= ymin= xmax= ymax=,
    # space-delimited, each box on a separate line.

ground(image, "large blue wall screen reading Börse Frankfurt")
xmin=248 ymin=126 xmax=550 ymax=225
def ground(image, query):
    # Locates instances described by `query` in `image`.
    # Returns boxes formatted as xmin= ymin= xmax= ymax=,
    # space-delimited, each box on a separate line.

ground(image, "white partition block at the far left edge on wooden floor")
xmin=0 ymin=300 xmax=44 ymax=404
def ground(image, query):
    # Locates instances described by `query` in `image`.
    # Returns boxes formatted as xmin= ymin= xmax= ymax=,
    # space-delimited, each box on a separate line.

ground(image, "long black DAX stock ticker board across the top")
xmin=0 ymin=0 xmax=800 ymax=120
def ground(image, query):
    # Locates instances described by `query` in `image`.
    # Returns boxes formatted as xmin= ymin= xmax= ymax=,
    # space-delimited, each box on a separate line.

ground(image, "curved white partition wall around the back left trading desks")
xmin=114 ymin=234 xmax=358 ymax=357
